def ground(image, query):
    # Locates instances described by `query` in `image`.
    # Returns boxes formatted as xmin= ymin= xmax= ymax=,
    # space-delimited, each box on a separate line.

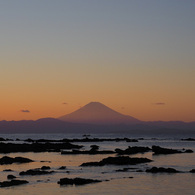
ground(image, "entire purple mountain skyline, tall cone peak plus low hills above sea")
xmin=0 ymin=102 xmax=195 ymax=137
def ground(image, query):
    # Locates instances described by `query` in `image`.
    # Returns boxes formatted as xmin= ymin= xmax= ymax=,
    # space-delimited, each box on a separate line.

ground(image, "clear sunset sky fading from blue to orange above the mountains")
xmin=0 ymin=0 xmax=195 ymax=121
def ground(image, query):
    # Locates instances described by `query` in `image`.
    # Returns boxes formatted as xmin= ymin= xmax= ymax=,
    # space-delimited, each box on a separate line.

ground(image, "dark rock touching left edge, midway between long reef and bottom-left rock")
xmin=0 ymin=156 xmax=33 ymax=165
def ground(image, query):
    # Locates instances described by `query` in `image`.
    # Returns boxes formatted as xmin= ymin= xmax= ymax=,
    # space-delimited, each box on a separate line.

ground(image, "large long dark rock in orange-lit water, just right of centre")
xmin=80 ymin=156 xmax=152 ymax=166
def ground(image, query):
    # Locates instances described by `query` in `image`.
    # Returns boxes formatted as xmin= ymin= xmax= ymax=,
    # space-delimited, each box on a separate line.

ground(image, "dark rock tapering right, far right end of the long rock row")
xmin=152 ymin=146 xmax=193 ymax=154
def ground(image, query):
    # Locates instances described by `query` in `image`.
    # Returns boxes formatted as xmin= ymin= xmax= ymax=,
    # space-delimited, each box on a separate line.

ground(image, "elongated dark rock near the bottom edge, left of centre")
xmin=58 ymin=178 xmax=101 ymax=185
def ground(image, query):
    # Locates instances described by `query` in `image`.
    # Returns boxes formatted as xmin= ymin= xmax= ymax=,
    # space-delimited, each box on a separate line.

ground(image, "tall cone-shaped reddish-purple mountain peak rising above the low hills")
xmin=58 ymin=102 xmax=141 ymax=124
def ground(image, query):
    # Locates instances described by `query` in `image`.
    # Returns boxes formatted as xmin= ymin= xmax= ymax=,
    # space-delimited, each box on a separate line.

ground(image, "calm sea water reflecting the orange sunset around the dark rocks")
xmin=0 ymin=134 xmax=195 ymax=195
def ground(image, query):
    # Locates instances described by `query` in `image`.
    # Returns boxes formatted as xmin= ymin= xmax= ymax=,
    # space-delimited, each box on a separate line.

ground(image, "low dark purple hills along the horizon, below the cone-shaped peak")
xmin=0 ymin=118 xmax=195 ymax=137
